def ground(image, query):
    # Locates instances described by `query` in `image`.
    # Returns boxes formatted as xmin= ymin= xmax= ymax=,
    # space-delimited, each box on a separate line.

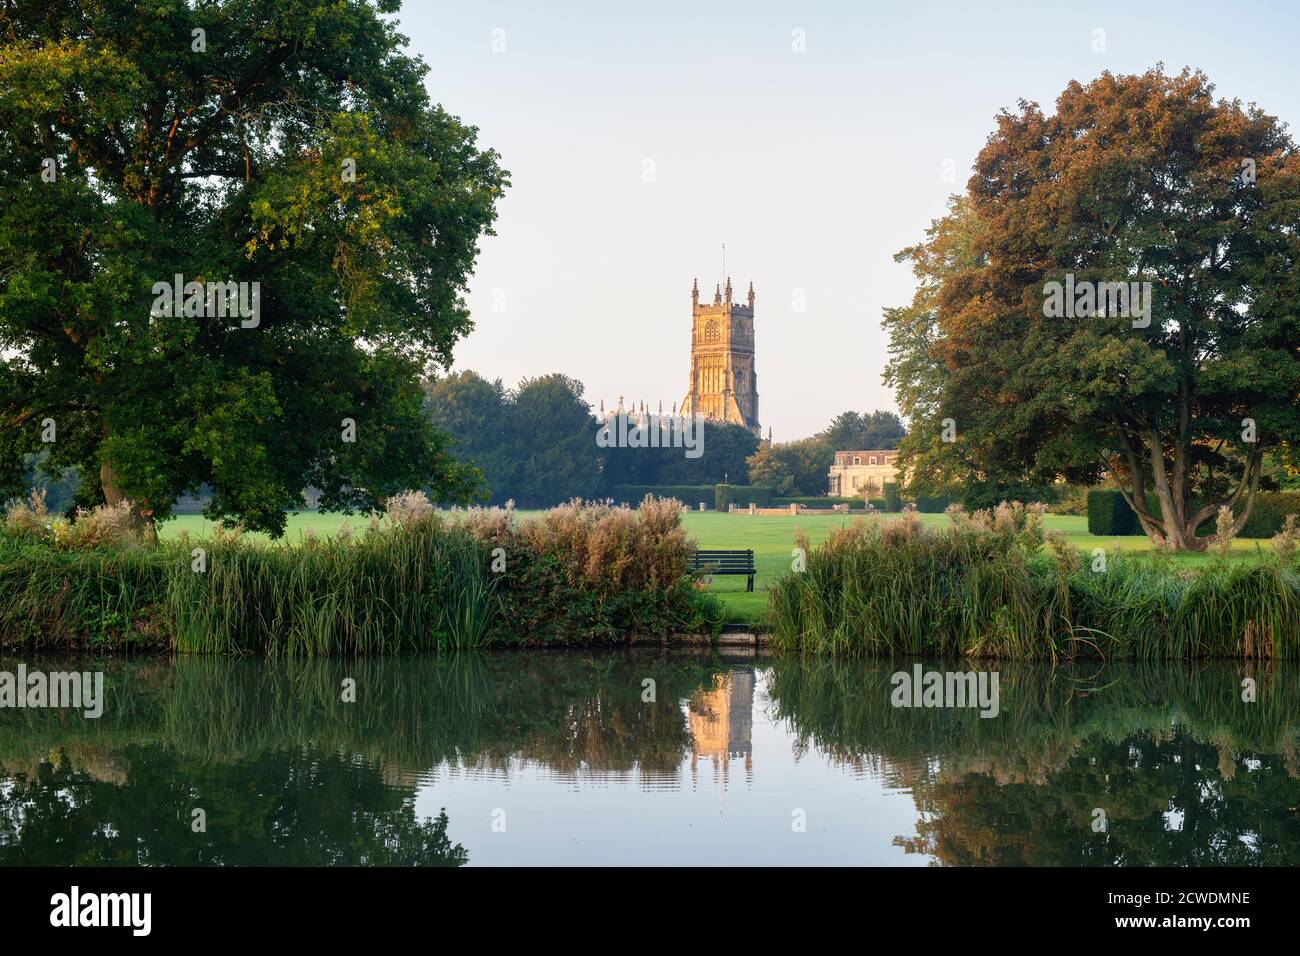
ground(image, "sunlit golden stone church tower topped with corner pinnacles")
xmin=681 ymin=278 xmax=761 ymax=434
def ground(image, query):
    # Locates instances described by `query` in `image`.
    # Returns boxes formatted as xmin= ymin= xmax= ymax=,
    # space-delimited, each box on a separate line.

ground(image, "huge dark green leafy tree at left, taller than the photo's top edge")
xmin=0 ymin=0 xmax=507 ymax=533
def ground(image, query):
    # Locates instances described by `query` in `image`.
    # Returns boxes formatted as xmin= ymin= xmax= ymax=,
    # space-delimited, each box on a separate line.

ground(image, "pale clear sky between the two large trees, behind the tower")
xmin=399 ymin=0 xmax=1300 ymax=441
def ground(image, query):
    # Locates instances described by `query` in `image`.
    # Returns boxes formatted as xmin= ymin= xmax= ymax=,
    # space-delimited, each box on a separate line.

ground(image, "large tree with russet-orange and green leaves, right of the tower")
xmin=885 ymin=69 xmax=1300 ymax=549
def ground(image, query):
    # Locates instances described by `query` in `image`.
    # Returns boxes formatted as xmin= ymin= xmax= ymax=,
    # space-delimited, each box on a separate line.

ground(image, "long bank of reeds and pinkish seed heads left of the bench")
xmin=0 ymin=492 xmax=723 ymax=656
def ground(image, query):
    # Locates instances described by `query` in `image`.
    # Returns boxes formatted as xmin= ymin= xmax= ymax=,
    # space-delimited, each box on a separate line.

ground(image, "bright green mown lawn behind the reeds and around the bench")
xmin=159 ymin=511 xmax=1271 ymax=624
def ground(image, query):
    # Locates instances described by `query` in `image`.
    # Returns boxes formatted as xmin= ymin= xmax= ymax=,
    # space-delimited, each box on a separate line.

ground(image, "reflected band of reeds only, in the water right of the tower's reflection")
xmin=770 ymin=658 xmax=1300 ymax=786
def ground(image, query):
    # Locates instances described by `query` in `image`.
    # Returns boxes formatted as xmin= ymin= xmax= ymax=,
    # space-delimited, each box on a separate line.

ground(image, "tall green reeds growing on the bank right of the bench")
xmin=768 ymin=522 xmax=1300 ymax=659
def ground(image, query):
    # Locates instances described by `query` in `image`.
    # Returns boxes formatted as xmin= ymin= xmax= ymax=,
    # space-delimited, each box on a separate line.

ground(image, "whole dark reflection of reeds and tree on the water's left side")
xmin=0 ymin=653 xmax=718 ymax=865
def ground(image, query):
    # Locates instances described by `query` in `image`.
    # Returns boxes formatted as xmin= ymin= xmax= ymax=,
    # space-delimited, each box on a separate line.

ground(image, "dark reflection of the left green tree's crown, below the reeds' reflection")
xmin=0 ymin=744 xmax=468 ymax=866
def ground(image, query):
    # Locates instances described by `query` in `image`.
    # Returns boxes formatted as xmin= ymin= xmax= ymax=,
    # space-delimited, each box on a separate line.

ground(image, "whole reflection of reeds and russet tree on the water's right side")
xmin=771 ymin=661 xmax=1300 ymax=866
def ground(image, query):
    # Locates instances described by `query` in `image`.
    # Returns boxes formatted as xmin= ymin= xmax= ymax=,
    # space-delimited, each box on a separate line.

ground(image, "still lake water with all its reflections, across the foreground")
xmin=0 ymin=648 xmax=1300 ymax=866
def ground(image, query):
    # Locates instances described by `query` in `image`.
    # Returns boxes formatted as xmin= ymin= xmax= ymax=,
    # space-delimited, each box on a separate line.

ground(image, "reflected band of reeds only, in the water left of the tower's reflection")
xmin=0 ymin=653 xmax=716 ymax=773
